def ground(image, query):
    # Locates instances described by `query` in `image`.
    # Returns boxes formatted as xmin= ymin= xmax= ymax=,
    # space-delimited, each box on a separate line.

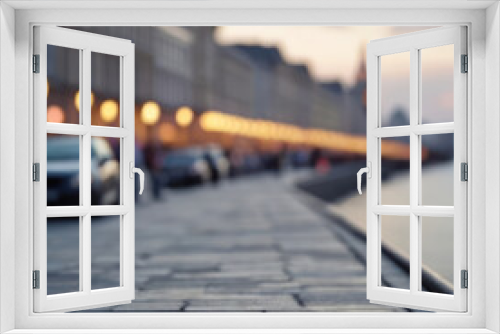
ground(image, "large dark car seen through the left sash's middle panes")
xmin=47 ymin=136 xmax=120 ymax=205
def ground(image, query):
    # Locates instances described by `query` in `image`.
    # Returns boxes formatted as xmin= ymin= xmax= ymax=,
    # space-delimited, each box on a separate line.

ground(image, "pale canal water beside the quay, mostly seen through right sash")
xmin=329 ymin=162 xmax=453 ymax=283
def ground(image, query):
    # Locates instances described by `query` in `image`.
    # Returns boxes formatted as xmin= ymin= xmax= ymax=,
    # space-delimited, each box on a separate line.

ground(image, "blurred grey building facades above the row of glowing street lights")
xmin=54 ymin=27 xmax=366 ymax=150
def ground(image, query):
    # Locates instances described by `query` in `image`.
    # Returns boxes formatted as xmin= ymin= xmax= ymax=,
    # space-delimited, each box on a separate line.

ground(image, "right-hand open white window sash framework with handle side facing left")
xmin=367 ymin=26 xmax=470 ymax=312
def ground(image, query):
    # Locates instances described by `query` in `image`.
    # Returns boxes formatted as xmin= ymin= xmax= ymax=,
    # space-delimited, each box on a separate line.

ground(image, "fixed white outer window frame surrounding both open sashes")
xmin=0 ymin=0 xmax=500 ymax=333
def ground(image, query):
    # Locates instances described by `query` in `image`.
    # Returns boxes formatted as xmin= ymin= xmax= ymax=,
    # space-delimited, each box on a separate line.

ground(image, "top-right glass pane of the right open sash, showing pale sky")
xmin=420 ymin=45 xmax=454 ymax=123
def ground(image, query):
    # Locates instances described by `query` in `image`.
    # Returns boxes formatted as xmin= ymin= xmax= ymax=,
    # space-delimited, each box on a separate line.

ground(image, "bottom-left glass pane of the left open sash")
xmin=47 ymin=217 xmax=80 ymax=295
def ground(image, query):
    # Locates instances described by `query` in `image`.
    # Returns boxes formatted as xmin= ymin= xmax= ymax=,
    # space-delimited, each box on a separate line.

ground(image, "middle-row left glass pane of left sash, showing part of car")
xmin=47 ymin=134 xmax=80 ymax=206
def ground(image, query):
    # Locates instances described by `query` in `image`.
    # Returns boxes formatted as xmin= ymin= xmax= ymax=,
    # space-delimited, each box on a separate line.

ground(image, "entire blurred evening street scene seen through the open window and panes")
xmin=46 ymin=26 xmax=455 ymax=312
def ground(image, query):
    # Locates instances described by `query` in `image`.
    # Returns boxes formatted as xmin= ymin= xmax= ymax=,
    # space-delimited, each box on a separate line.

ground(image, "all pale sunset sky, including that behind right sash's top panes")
xmin=215 ymin=26 xmax=453 ymax=122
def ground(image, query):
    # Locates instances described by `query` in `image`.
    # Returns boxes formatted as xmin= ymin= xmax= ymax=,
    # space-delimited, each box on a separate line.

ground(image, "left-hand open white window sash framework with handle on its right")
xmin=33 ymin=26 xmax=135 ymax=312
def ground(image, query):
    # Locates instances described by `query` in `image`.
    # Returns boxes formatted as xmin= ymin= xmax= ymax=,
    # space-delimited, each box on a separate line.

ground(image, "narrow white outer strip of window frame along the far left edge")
xmin=0 ymin=3 xmax=15 ymax=333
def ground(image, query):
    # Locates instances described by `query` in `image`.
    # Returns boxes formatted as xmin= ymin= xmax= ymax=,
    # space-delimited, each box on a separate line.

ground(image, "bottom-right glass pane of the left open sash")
xmin=91 ymin=216 xmax=121 ymax=290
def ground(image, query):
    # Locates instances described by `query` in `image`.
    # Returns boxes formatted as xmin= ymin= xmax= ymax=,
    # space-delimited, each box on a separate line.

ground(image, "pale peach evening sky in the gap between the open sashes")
xmin=216 ymin=26 xmax=436 ymax=84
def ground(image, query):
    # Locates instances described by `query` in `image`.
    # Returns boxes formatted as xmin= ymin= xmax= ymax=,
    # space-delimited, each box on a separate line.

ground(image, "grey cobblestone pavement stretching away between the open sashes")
xmin=49 ymin=175 xmax=404 ymax=312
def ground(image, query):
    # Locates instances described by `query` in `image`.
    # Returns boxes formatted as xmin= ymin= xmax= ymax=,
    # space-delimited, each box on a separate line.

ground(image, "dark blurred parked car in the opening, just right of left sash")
xmin=162 ymin=148 xmax=210 ymax=187
